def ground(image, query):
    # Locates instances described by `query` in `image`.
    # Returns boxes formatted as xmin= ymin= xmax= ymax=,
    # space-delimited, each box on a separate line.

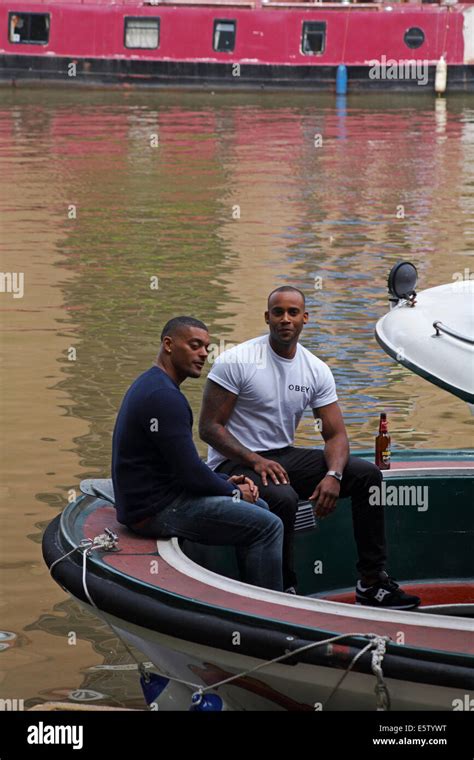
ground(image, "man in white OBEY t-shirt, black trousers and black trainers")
xmin=199 ymin=286 xmax=420 ymax=609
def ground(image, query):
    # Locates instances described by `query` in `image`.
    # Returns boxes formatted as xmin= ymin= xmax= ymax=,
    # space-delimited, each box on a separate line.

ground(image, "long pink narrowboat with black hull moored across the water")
xmin=0 ymin=0 xmax=474 ymax=94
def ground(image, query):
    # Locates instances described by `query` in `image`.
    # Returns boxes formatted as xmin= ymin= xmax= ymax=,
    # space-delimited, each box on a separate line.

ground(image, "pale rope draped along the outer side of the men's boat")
xmin=49 ymin=528 xmax=391 ymax=711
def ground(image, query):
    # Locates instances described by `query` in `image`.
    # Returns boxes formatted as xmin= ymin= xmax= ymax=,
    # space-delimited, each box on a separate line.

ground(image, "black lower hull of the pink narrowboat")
xmin=0 ymin=55 xmax=474 ymax=95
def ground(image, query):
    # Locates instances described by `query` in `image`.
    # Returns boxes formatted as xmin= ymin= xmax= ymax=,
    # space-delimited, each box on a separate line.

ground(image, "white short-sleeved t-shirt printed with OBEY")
xmin=207 ymin=335 xmax=337 ymax=470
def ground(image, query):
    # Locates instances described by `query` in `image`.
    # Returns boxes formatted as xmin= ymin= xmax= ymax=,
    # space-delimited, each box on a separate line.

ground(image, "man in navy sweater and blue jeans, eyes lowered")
xmin=112 ymin=317 xmax=283 ymax=591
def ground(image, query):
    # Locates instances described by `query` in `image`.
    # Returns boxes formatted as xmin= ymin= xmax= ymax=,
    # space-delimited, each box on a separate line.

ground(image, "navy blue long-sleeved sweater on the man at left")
xmin=112 ymin=366 xmax=236 ymax=525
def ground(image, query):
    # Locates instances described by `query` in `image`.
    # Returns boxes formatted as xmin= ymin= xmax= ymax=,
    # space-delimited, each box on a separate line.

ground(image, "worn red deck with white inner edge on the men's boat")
xmin=78 ymin=492 xmax=474 ymax=654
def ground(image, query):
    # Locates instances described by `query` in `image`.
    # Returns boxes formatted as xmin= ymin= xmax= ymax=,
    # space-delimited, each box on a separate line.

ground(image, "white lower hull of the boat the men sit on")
xmin=81 ymin=600 xmax=465 ymax=711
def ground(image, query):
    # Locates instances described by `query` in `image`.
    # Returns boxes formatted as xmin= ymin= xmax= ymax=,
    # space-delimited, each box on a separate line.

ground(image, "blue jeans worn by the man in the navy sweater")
xmin=130 ymin=494 xmax=283 ymax=591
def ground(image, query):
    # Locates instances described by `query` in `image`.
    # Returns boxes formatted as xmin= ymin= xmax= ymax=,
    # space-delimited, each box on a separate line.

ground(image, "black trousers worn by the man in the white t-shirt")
xmin=217 ymin=446 xmax=386 ymax=588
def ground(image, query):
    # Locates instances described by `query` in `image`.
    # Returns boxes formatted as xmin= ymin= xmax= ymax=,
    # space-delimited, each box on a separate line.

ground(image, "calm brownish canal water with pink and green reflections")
xmin=0 ymin=90 xmax=474 ymax=707
